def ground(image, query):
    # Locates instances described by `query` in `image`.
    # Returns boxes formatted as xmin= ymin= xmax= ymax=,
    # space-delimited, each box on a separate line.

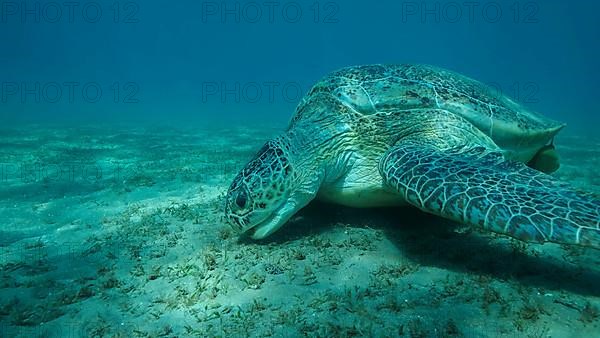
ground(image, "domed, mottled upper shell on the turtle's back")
xmin=294 ymin=65 xmax=559 ymax=135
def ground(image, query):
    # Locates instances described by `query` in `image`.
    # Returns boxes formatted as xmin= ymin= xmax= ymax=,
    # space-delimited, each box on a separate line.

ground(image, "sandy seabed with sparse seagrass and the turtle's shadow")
xmin=0 ymin=126 xmax=600 ymax=337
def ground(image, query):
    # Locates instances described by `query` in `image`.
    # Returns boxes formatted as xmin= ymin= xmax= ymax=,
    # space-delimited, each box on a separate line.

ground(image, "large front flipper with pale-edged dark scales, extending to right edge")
xmin=380 ymin=141 xmax=600 ymax=248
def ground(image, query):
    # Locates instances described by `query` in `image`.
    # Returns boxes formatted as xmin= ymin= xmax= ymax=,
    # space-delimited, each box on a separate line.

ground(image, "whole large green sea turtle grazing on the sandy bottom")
xmin=225 ymin=65 xmax=600 ymax=248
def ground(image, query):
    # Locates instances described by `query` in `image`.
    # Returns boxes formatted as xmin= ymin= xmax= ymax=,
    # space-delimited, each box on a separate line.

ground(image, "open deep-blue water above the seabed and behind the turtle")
xmin=0 ymin=0 xmax=600 ymax=127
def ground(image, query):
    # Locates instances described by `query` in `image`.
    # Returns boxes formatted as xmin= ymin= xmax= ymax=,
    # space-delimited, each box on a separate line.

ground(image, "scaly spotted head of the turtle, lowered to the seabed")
xmin=225 ymin=138 xmax=308 ymax=239
